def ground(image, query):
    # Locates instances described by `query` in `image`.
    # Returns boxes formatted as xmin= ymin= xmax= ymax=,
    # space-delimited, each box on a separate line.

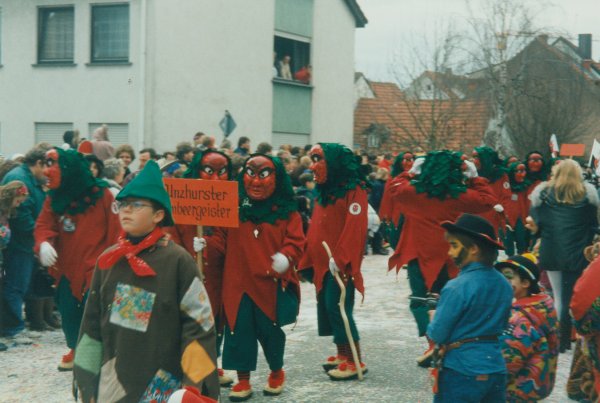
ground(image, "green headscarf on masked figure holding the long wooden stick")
xmin=316 ymin=143 xmax=367 ymax=206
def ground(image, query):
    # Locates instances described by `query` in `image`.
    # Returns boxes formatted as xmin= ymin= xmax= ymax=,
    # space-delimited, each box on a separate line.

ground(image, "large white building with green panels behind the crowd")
xmin=0 ymin=0 xmax=367 ymax=154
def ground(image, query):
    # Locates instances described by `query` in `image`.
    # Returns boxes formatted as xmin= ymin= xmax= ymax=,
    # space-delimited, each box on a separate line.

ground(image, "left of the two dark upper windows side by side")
xmin=38 ymin=6 xmax=75 ymax=64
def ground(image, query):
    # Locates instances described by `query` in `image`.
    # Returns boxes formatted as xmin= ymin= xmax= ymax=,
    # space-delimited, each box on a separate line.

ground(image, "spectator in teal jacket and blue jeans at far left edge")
xmin=2 ymin=147 xmax=46 ymax=338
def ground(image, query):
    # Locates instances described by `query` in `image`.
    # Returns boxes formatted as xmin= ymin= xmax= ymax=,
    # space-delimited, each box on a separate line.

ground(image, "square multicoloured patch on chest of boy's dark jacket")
xmin=110 ymin=283 xmax=156 ymax=332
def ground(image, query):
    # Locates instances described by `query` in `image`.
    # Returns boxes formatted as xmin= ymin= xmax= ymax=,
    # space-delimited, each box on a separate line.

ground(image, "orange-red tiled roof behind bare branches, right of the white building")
xmin=354 ymin=82 xmax=491 ymax=152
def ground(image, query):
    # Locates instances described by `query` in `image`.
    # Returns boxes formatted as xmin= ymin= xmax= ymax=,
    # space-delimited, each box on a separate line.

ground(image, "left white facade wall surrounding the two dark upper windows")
xmin=0 ymin=0 xmax=141 ymax=155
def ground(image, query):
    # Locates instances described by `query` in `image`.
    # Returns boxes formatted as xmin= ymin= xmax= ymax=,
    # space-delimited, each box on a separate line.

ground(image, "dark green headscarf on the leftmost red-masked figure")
xmin=48 ymin=147 xmax=108 ymax=215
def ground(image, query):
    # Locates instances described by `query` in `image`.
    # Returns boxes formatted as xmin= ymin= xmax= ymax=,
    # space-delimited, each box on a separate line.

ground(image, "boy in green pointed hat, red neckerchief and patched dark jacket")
xmin=74 ymin=161 xmax=219 ymax=402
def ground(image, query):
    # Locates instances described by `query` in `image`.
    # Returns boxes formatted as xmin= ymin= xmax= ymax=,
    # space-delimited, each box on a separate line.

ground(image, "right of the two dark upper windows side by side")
xmin=91 ymin=4 xmax=129 ymax=63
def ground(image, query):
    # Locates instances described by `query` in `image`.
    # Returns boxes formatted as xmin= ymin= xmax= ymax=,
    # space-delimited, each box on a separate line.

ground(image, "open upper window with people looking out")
xmin=273 ymin=35 xmax=312 ymax=85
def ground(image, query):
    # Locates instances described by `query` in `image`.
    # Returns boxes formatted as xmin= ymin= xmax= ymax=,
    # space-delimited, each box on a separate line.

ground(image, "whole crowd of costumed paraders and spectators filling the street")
xmin=0 ymin=126 xmax=600 ymax=403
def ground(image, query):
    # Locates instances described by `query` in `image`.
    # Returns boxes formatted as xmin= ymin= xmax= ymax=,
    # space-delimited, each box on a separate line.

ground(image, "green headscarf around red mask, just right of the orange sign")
xmin=238 ymin=154 xmax=298 ymax=224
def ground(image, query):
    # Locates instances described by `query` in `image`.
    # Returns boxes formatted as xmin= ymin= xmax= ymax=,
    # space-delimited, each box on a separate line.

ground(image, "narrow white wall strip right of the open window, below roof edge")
xmin=311 ymin=0 xmax=356 ymax=147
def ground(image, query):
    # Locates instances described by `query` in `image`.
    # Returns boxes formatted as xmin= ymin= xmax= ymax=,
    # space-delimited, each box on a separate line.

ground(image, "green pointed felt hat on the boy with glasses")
xmin=116 ymin=160 xmax=174 ymax=226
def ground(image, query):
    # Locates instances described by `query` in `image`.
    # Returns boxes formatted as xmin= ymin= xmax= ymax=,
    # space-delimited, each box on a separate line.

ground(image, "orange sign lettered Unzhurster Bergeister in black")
xmin=163 ymin=178 xmax=239 ymax=228
